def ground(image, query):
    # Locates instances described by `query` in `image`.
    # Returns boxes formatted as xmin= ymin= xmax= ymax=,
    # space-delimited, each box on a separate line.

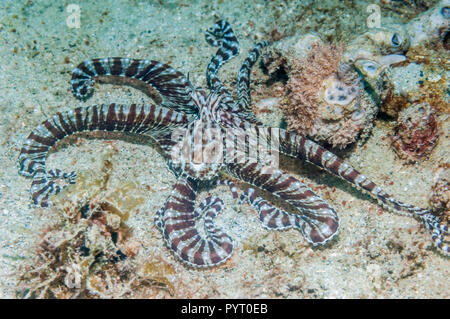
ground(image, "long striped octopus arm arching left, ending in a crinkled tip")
xmin=18 ymin=103 xmax=188 ymax=207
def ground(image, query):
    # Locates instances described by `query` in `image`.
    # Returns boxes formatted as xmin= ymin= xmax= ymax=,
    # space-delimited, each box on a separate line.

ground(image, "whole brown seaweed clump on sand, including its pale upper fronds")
xmin=16 ymin=156 xmax=174 ymax=299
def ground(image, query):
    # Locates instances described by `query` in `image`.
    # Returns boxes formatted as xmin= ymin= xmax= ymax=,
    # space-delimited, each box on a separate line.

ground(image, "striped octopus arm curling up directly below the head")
xmin=155 ymin=176 xmax=233 ymax=267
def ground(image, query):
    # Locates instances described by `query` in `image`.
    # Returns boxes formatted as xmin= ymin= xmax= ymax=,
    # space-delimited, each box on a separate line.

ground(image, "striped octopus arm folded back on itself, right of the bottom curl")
xmin=227 ymin=160 xmax=339 ymax=245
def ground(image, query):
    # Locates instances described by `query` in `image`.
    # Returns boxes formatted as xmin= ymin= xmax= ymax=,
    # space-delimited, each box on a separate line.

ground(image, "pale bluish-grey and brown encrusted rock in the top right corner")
xmin=343 ymin=0 xmax=450 ymax=117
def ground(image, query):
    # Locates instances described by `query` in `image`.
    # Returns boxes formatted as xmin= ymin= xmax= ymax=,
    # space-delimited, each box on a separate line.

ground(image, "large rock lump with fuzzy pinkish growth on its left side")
xmin=281 ymin=42 xmax=377 ymax=148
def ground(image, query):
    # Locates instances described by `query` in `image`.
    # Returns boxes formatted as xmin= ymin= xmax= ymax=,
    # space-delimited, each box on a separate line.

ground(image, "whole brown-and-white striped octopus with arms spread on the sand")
xmin=18 ymin=20 xmax=450 ymax=267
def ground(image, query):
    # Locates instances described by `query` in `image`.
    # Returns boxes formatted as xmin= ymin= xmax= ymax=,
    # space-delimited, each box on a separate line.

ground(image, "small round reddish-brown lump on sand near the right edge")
xmin=391 ymin=103 xmax=439 ymax=163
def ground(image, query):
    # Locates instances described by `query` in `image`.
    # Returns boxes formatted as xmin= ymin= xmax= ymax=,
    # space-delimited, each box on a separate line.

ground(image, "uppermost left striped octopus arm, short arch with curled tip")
xmin=70 ymin=57 xmax=198 ymax=114
